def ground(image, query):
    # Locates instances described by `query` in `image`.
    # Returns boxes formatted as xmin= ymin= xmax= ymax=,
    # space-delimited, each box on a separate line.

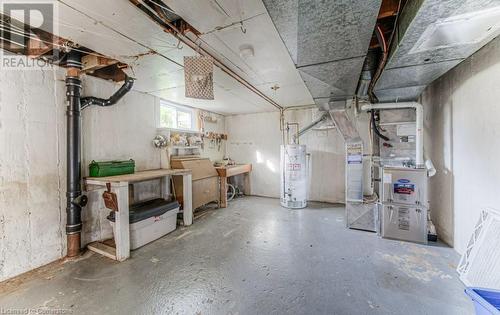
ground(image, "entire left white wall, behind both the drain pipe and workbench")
xmin=0 ymin=69 xmax=224 ymax=281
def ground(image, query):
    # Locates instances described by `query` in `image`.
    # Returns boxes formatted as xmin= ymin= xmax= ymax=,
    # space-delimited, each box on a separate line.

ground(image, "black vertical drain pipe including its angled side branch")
xmin=66 ymin=50 xmax=134 ymax=257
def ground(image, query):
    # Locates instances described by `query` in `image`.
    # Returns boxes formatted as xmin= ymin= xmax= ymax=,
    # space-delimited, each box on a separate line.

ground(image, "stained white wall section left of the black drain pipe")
xmin=0 ymin=70 xmax=65 ymax=280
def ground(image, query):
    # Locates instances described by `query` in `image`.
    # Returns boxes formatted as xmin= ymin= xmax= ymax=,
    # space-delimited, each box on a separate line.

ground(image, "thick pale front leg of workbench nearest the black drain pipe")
xmin=113 ymin=183 xmax=130 ymax=261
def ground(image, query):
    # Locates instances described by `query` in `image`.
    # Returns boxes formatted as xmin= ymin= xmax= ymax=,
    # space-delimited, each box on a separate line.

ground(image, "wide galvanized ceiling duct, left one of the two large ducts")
xmin=264 ymin=0 xmax=382 ymax=110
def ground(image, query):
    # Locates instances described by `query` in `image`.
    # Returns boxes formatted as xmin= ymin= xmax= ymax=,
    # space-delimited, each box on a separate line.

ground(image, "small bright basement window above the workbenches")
xmin=159 ymin=100 xmax=195 ymax=130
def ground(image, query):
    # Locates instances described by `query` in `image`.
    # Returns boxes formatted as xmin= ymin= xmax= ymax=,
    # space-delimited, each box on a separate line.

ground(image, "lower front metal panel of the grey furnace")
xmin=380 ymin=204 xmax=427 ymax=244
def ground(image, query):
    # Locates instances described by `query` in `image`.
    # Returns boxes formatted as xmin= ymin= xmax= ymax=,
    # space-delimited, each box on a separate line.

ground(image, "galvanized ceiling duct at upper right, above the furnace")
xmin=375 ymin=0 xmax=500 ymax=102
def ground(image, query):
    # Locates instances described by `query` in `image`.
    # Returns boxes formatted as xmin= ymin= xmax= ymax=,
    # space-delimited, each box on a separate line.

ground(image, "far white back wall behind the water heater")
xmin=226 ymin=109 xmax=345 ymax=202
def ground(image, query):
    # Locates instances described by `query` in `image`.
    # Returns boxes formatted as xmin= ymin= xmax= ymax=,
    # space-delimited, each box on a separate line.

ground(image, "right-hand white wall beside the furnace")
xmin=421 ymin=37 xmax=500 ymax=253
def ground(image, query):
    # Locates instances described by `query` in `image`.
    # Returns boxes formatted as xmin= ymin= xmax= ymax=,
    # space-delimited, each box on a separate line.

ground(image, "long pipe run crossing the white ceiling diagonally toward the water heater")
xmin=130 ymin=0 xmax=283 ymax=110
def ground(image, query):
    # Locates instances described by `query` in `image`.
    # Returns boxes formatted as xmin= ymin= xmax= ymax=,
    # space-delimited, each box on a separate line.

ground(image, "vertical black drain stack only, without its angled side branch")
xmin=66 ymin=51 xmax=82 ymax=257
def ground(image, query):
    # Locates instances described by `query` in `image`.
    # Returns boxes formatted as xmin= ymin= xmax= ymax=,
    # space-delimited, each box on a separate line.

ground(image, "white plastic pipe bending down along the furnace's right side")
xmin=361 ymin=102 xmax=424 ymax=167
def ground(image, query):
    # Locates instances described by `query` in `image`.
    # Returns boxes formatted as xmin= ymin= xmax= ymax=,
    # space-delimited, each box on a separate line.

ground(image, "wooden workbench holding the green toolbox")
xmin=84 ymin=169 xmax=193 ymax=261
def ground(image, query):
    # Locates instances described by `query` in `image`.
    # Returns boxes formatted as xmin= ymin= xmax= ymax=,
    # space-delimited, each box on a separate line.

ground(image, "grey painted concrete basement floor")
xmin=0 ymin=197 xmax=473 ymax=315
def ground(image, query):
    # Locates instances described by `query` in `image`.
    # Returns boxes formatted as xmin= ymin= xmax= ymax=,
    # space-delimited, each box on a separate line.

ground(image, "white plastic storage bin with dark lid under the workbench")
xmin=108 ymin=199 xmax=179 ymax=250
